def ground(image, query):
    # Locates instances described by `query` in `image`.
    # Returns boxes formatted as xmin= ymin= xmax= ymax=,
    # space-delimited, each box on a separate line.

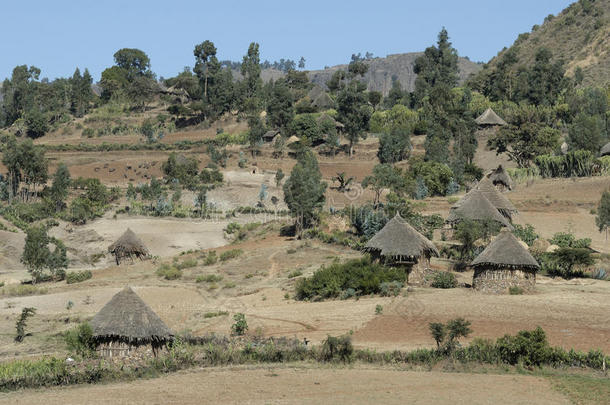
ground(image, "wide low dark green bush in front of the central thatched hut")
xmin=295 ymin=257 xmax=406 ymax=300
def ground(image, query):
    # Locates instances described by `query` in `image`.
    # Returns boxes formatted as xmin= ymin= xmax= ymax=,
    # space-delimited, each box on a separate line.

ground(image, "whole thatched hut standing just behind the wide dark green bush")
xmin=364 ymin=213 xmax=439 ymax=280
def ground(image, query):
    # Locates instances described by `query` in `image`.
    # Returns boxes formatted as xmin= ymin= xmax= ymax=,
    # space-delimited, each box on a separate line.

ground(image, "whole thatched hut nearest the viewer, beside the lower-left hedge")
xmin=91 ymin=287 xmax=174 ymax=357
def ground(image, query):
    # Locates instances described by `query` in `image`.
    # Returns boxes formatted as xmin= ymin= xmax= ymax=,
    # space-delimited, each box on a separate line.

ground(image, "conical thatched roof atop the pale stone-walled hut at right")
xmin=471 ymin=231 xmax=540 ymax=269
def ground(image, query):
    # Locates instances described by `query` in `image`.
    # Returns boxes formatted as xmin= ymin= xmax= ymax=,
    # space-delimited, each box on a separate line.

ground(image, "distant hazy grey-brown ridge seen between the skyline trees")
xmin=243 ymin=52 xmax=481 ymax=96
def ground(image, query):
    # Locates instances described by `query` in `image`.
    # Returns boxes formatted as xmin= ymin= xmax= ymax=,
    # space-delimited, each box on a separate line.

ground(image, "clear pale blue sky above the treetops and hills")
xmin=0 ymin=0 xmax=572 ymax=80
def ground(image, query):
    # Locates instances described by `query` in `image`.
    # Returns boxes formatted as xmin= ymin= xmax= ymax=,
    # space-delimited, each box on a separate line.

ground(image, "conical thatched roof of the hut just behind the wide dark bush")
xmin=364 ymin=213 xmax=438 ymax=258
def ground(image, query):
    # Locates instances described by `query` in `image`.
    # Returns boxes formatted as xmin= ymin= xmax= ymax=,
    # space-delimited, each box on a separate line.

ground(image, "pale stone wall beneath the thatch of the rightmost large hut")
xmin=472 ymin=267 xmax=536 ymax=294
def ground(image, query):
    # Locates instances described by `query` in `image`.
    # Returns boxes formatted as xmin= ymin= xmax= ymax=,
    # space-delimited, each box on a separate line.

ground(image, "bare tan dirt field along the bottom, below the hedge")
xmin=0 ymin=367 xmax=570 ymax=405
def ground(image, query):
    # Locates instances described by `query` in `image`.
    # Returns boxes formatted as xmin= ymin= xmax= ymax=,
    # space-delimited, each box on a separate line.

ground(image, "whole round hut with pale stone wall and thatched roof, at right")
xmin=470 ymin=231 xmax=540 ymax=293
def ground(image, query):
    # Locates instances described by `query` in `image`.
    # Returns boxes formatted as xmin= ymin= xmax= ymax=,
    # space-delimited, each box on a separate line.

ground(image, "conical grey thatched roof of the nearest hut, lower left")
xmin=91 ymin=287 xmax=174 ymax=344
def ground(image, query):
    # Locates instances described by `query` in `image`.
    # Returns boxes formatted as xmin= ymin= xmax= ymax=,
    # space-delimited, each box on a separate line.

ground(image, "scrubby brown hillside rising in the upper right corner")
xmin=478 ymin=0 xmax=610 ymax=86
